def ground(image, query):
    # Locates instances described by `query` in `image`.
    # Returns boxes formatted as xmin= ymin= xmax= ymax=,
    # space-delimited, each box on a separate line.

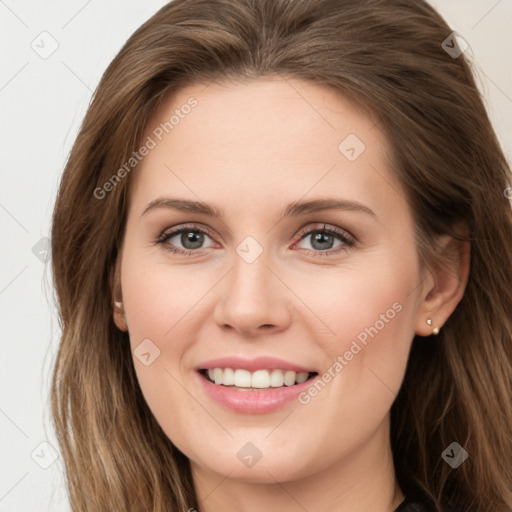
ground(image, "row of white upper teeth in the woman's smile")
xmin=203 ymin=368 xmax=309 ymax=389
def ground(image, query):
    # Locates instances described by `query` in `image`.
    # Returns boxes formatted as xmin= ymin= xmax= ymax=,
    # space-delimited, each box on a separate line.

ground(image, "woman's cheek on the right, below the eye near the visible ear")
xmin=299 ymin=251 xmax=418 ymax=416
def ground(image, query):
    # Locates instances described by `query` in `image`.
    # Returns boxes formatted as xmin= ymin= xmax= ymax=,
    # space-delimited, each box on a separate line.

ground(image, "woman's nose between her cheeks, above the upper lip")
xmin=213 ymin=246 xmax=292 ymax=338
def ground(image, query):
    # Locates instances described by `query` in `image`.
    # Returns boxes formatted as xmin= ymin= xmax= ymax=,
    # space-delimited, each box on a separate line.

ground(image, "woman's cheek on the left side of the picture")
xmin=121 ymin=251 xmax=214 ymax=420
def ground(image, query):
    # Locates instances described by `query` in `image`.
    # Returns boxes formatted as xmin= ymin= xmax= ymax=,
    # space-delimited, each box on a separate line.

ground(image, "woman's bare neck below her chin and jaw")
xmin=191 ymin=415 xmax=404 ymax=512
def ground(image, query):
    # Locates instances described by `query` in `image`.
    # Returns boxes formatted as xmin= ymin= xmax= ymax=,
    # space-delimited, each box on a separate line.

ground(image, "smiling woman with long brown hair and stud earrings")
xmin=52 ymin=0 xmax=512 ymax=512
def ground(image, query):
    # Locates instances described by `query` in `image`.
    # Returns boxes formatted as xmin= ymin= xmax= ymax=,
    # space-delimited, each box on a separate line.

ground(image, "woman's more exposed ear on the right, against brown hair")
xmin=415 ymin=235 xmax=470 ymax=336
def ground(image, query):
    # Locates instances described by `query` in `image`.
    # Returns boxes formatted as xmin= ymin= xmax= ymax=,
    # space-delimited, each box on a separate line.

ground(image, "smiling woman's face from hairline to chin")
xmin=117 ymin=78 xmax=425 ymax=483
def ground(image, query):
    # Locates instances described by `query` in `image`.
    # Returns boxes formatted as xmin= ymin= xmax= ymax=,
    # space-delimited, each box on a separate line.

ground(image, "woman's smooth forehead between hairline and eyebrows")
xmin=126 ymin=78 xmax=399 ymax=217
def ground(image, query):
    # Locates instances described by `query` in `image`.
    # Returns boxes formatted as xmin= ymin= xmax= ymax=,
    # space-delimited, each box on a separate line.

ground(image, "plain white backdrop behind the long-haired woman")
xmin=0 ymin=0 xmax=512 ymax=512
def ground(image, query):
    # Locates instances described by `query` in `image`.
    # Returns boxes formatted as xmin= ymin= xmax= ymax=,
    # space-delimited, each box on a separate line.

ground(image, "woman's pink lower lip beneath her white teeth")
xmin=197 ymin=372 xmax=316 ymax=414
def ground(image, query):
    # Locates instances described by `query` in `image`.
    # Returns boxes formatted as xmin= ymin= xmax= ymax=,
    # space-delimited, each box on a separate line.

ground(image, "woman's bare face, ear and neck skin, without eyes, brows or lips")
xmin=114 ymin=77 xmax=468 ymax=512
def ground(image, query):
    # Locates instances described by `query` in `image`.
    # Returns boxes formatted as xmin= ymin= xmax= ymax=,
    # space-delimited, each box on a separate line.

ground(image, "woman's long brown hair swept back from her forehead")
xmin=51 ymin=0 xmax=512 ymax=512
